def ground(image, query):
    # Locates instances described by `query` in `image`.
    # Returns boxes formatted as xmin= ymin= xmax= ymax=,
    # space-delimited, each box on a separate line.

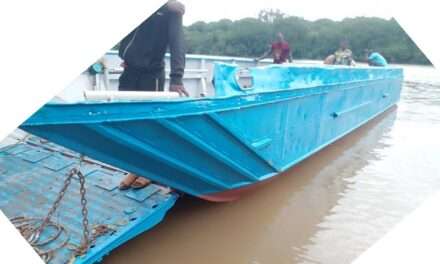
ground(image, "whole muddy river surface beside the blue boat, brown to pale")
xmin=105 ymin=67 xmax=440 ymax=264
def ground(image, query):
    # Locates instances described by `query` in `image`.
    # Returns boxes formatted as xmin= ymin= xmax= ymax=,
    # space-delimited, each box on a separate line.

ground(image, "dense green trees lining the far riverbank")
xmin=185 ymin=10 xmax=430 ymax=64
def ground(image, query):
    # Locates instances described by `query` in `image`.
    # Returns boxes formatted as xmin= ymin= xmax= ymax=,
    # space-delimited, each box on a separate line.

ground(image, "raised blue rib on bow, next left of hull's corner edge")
xmin=157 ymin=119 xmax=259 ymax=181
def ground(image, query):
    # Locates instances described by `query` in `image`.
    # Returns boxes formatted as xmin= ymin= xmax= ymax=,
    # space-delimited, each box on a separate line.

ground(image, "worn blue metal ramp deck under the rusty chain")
xmin=0 ymin=137 xmax=178 ymax=263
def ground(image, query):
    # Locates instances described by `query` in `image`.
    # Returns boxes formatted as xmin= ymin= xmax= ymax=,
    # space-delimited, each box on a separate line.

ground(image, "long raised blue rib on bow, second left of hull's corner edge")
xmin=90 ymin=125 xmax=229 ymax=189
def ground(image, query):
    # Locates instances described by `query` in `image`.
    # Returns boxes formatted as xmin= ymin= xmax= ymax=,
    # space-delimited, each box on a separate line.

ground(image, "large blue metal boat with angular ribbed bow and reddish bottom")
xmin=21 ymin=64 xmax=403 ymax=201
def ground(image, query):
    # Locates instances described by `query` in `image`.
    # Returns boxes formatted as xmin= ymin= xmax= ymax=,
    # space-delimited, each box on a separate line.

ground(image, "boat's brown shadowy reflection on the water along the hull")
xmin=106 ymin=106 xmax=397 ymax=263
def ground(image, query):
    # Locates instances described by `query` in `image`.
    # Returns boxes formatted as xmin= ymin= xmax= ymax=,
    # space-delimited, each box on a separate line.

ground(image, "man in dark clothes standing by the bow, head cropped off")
xmin=119 ymin=0 xmax=188 ymax=189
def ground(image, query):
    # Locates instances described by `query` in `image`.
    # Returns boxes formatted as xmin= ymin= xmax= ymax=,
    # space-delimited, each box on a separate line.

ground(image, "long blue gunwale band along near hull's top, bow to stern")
xmin=21 ymin=75 xmax=403 ymax=126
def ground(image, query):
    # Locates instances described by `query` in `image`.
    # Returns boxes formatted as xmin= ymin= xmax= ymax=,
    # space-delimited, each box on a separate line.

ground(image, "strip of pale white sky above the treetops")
xmin=180 ymin=0 xmax=392 ymax=25
